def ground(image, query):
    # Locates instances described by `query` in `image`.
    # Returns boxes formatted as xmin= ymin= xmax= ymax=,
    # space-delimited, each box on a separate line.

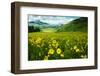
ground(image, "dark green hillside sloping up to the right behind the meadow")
xmin=57 ymin=17 xmax=88 ymax=32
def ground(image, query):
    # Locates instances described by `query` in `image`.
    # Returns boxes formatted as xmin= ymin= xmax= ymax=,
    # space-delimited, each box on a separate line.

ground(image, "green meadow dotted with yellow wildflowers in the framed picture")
xmin=28 ymin=32 xmax=88 ymax=61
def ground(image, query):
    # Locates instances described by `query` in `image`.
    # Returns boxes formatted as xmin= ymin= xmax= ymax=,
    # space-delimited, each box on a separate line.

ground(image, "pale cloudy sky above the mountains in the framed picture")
xmin=28 ymin=15 xmax=79 ymax=25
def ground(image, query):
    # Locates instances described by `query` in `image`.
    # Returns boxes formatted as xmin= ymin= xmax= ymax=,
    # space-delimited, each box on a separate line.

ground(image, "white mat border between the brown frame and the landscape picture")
xmin=20 ymin=7 xmax=94 ymax=70
